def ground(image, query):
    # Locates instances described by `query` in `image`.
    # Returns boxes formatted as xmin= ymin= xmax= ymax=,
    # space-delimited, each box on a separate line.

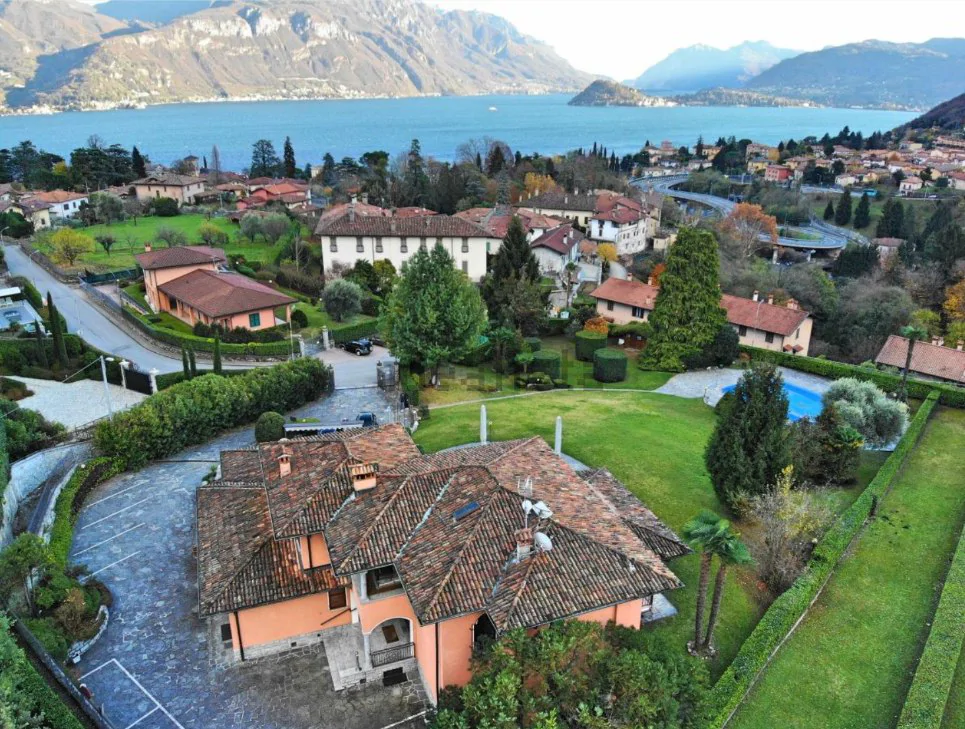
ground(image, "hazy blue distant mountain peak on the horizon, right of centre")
xmin=626 ymin=41 xmax=798 ymax=94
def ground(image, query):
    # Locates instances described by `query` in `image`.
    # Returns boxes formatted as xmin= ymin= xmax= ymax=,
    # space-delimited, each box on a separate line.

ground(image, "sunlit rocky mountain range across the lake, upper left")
xmin=0 ymin=0 xmax=592 ymax=109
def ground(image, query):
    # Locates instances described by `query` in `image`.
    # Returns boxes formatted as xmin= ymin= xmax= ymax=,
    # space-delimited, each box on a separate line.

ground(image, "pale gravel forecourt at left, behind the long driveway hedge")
xmin=10 ymin=375 xmax=147 ymax=430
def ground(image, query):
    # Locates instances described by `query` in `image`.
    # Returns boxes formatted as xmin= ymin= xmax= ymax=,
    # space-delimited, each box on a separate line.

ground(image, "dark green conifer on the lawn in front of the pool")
xmin=704 ymin=362 xmax=790 ymax=510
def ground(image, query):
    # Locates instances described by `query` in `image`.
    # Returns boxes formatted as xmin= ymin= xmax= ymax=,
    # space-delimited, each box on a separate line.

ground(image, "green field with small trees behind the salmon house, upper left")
xmin=38 ymin=215 xmax=275 ymax=271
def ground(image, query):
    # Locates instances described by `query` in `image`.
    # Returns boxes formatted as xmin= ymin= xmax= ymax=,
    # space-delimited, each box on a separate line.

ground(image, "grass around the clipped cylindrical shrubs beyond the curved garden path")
xmin=422 ymin=337 xmax=673 ymax=406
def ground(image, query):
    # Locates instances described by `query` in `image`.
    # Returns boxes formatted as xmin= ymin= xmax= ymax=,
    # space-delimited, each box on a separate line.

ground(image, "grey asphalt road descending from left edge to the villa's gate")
xmin=3 ymin=245 xmax=380 ymax=388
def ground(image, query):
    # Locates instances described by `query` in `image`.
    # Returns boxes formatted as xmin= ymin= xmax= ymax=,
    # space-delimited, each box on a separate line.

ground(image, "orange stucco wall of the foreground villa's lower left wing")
xmin=229 ymin=592 xmax=352 ymax=650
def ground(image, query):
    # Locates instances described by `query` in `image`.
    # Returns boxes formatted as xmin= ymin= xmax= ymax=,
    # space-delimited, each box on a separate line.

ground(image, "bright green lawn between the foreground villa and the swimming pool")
xmin=415 ymin=391 xmax=762 ymax=677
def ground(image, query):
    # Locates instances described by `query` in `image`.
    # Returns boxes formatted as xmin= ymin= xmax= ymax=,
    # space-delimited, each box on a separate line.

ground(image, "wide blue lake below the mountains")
xmin=0 ymin=94 xmax=916 ymax=170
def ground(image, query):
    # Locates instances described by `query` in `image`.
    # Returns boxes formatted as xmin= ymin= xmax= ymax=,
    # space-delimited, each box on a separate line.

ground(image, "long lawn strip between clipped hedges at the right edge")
xmin=730 ymin=410 xmax=965 ymax=729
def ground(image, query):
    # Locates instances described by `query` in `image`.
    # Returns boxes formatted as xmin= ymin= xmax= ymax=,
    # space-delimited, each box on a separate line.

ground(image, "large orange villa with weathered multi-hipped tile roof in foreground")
xmin=197 ymin=424 xmax=690 ymax=701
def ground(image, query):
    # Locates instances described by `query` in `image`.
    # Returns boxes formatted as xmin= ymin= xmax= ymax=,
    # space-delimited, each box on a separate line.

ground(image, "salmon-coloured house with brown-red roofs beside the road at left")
xmin=134 ymin=245 xmax=295 ymax=329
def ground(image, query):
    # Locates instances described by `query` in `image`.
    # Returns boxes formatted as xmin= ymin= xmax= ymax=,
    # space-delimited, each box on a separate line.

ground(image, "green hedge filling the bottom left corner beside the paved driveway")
xmin=0 ymin=614 xmax=84 ymax=729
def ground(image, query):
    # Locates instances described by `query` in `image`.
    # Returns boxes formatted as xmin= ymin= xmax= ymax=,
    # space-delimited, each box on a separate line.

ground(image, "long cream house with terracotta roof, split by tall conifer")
xmin=590 ymin=278 xmax=813 ymax=355
